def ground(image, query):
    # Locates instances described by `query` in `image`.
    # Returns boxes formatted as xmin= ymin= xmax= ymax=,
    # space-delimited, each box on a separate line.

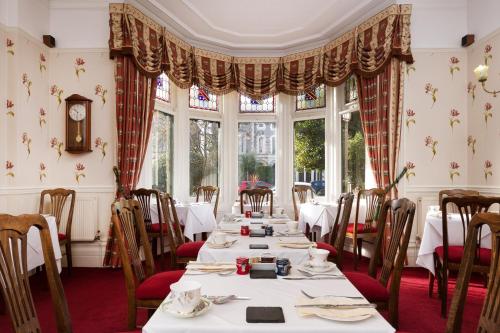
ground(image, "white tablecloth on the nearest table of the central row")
xmin=142 ymin=269 xmax=394 ymax=333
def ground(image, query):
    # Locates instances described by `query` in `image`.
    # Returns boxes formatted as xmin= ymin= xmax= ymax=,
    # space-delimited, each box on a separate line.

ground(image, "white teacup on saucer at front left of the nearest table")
xmin=170 ymin=281 xmax=201 ymax=313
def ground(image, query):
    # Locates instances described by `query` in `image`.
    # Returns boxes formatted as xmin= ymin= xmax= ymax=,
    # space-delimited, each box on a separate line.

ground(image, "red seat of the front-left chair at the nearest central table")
xmin=135 ymin=269 xmax=185 ymax=299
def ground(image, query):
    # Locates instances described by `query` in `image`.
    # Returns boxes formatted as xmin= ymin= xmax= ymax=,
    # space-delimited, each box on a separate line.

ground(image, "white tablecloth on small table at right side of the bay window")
xmin=299 ymin=202 xmax=366 ymax=237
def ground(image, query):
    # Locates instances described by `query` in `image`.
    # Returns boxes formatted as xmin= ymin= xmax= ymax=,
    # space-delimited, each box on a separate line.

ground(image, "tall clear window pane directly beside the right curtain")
xmin=340 ymin=111 xmax=366 ymax=192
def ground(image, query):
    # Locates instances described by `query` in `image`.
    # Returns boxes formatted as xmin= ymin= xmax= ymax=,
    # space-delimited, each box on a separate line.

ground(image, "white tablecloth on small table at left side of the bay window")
xmin=151 ymin=203 xmax=217 ymax=241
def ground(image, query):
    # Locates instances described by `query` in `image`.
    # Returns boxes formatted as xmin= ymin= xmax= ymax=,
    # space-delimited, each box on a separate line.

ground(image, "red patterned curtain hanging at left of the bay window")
xmin=103 ymin=55 xmax=156 ymax=267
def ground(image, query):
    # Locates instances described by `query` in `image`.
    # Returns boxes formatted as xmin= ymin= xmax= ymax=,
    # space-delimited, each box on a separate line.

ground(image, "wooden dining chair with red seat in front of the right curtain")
xmin=346 ymin=188 xmax=386 ymax=270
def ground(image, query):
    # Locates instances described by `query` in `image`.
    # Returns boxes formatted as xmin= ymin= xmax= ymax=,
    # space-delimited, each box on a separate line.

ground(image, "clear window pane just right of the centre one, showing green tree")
xmin=293 ymin=119 xmax=325 ymax=196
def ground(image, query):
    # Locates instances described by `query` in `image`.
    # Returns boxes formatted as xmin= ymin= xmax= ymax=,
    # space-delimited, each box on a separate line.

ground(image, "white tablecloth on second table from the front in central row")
xmin=197 ymin=235 xmax=309 ymax=265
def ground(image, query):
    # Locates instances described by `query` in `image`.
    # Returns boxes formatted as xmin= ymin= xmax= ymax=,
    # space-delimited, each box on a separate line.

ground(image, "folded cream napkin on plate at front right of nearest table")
xmin=296 ymin=296 xmax=377 ymax=321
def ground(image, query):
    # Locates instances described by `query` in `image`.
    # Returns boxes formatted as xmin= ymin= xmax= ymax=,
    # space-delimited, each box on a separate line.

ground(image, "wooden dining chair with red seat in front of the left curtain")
xmin=130 ymin=188 xmax=167 ymax=269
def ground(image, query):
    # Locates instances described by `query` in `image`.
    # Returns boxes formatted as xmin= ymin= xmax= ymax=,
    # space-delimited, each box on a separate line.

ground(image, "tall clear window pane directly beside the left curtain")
xmin=150 ymin=111 xmax=174 ymax=193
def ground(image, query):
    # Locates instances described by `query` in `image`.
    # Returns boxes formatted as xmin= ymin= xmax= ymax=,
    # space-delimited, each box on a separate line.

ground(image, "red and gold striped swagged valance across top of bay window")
xmin=109 ymin=3 xmax=413 ymax=98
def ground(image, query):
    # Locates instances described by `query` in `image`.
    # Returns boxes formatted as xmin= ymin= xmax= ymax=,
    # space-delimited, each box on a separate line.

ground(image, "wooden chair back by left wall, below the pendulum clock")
xmin=38 ymin=188 xmax=76 ymax=239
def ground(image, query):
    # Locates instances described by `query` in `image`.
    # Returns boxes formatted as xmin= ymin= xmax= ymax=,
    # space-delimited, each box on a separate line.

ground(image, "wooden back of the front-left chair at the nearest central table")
xmin=111 ymin=199 xmax=154 ymax=290
